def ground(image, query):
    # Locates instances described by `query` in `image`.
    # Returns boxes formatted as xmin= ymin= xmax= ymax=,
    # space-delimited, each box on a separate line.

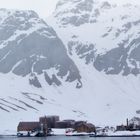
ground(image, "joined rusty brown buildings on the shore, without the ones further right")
xmin=17 ymin=116 xmax=96 ymax=136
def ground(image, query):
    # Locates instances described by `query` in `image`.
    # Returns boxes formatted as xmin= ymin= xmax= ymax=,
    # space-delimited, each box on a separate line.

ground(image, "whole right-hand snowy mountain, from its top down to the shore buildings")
xmin=48 ymin=0 xmax=140 ymax=124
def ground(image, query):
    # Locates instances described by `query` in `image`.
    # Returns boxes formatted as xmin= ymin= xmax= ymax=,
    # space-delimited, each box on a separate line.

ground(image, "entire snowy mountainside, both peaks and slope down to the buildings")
xmin=0 ymin=0 xmax=140 ymax=132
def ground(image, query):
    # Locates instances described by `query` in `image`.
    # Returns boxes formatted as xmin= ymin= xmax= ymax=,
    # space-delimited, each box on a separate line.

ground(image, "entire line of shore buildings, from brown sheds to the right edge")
xmin=17 ymin=115 xmax=140 ymax=137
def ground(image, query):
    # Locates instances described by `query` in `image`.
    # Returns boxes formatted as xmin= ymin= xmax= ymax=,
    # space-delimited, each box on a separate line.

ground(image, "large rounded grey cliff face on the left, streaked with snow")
xmin=0 ymin=9 xmax=81 ymax=87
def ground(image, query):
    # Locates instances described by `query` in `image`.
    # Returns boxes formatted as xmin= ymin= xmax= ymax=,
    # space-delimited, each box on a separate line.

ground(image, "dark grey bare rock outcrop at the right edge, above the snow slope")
xmin=94 ymin=38 xmax=140 ymax=76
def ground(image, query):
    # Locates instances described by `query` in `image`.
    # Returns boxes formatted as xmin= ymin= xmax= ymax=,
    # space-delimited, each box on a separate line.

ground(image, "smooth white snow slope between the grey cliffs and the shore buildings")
xmin=0 ymin=55 xmax=140 ymax=133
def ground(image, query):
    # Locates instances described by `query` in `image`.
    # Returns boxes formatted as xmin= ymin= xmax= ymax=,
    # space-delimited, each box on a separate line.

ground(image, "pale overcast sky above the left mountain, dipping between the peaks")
xmin=0 ymin=0 xmax=58 ymax=17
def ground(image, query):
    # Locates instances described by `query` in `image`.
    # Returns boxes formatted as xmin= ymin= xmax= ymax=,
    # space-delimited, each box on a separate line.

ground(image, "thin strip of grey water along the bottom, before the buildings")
xmin=0 ymin=136 xmax=140 ymax=140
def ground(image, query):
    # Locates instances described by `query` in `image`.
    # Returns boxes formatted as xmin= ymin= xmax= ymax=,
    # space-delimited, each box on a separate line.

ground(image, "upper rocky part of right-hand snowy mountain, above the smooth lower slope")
xmin=52 ymin=0 xmax=140 ymax=76
